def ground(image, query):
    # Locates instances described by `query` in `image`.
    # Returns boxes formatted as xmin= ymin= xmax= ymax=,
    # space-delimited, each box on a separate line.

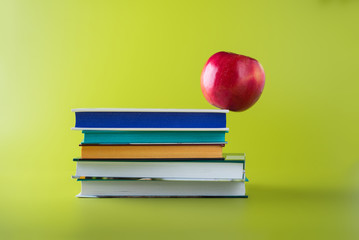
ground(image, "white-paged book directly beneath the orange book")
xmin=74 ymin=158 xmax=245 ymax=180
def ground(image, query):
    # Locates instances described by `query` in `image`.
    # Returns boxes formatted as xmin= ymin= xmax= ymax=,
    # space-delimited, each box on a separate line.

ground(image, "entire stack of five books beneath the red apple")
xmin=72 ymin=108 xmax=247 ymax=197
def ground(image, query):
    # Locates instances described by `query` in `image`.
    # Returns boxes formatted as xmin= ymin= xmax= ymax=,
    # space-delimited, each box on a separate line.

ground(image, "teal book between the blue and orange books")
xmin=82 ymin=130 xmax=227 ymax=144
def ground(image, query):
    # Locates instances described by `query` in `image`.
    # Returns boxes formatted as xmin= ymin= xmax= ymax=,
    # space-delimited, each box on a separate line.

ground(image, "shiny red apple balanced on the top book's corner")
xmin=201 ymin=52 xmax=265 ymax=112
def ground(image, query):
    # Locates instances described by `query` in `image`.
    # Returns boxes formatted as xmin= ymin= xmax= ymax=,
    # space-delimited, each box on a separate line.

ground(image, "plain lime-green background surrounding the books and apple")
xmin=0 ymin=0 xmax=359 ymax=239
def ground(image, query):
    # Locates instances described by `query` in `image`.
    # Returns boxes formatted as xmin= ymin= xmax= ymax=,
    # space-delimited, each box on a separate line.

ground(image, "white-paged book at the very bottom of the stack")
xmin=77 ymin=180 xmax=247 ymax=197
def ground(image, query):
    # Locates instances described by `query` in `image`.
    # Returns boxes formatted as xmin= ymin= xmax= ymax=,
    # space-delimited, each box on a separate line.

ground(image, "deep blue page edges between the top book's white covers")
xmin=76 ymin=112 xmax=226 ymax=128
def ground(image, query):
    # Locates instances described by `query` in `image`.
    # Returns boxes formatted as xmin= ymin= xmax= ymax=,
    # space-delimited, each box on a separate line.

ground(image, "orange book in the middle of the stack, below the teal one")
xmin=80 ymin=144 xmax=223 ymax=159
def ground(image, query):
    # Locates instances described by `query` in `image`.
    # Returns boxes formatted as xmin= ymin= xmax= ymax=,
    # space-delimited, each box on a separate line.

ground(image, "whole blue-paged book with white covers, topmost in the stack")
xmin=72 ymin=108 xmax=228 ymax=131
